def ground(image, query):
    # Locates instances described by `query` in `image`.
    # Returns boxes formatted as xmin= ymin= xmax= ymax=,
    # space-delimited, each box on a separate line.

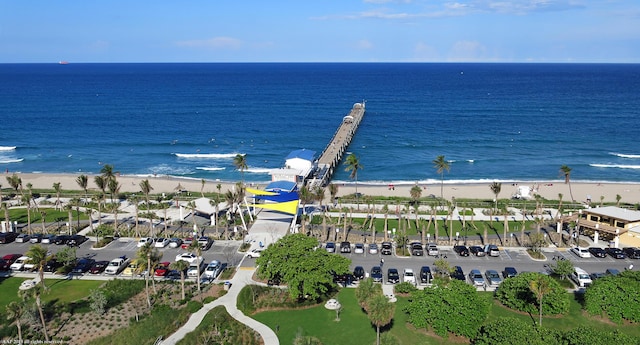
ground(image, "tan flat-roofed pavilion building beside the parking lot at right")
xmin=577 ymin=206 xmax=640 ymax=248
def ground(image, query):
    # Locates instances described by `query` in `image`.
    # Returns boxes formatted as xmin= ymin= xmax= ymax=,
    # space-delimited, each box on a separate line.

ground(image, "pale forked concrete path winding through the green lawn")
xmin=161 ymin=267 xmax=280 ymax=345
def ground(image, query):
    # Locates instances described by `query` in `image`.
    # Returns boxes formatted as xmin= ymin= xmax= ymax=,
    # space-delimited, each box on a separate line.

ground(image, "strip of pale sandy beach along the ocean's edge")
xmin=8 ymin=173 xmax=640 ymax=204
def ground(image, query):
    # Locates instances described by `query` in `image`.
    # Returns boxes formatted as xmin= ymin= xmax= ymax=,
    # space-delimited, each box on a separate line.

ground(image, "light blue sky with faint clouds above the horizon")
xmin=0 ymin=0 xmax=640 ymax=63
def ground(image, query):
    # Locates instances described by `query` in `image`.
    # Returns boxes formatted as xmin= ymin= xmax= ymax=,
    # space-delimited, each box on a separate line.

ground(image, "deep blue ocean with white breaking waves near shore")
xmin=0 ymin=63 xmax=640 ymax=184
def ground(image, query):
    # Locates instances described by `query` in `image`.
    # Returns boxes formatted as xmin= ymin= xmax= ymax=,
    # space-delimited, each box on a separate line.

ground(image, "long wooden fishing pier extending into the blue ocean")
xmin=308 ymin=102 xmax=365 ymax=187
